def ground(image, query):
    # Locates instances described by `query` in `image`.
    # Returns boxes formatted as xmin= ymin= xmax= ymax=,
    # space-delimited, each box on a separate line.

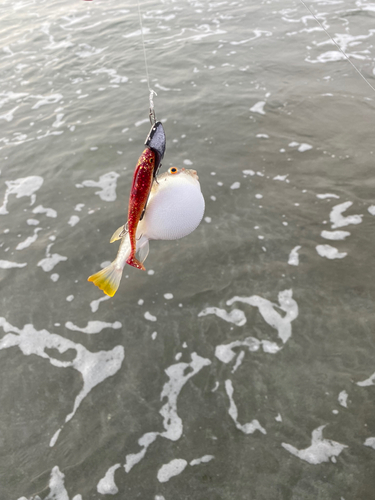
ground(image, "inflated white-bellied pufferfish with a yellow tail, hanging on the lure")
xmin=88 ymin=167 xmax=205 ymax=297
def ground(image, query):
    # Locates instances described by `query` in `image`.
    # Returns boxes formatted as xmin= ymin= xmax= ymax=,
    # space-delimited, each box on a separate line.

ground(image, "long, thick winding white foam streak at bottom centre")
xmin=124 ymin=352 xmax=211 ymax=472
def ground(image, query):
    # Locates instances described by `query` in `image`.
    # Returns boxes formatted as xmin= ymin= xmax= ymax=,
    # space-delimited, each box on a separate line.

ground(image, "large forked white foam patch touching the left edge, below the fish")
xmin=0 ymin=317 xmax=125 ymax=444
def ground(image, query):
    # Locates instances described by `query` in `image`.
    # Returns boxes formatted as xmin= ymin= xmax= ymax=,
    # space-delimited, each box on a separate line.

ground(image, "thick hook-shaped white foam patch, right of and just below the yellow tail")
xmin=227 ymin=290 xmax=298 ymax=343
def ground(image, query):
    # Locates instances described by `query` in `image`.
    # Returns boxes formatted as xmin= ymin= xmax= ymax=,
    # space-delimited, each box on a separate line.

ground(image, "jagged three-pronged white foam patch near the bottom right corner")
xmin=281 ymin=425 xmax=347 ymax=465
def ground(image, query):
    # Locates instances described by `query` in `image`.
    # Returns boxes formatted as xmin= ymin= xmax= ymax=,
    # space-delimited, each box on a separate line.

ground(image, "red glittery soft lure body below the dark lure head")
xmin=126 ymin=148 xmax=156 ymax=271
